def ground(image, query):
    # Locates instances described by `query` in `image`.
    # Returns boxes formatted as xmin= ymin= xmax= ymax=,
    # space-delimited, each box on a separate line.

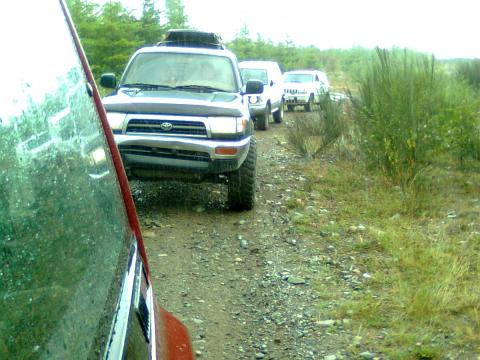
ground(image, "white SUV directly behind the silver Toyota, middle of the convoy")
xmin=239 ymin=61 xmax=284 ymax=130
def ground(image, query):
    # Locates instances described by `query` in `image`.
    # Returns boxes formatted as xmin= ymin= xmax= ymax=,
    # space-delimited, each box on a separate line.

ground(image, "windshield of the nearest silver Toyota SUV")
xmin=120 ymin=52 xmax=237 ymax=92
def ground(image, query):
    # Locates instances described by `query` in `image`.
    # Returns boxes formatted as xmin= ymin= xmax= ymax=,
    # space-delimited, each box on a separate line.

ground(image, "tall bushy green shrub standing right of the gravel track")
xmin=352 ymin=49 xmax=446 ymax=187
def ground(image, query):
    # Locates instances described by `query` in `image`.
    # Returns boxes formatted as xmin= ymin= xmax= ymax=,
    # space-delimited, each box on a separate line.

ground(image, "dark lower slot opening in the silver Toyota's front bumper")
xmin=118 ymin=145 xmax=210 ymax=162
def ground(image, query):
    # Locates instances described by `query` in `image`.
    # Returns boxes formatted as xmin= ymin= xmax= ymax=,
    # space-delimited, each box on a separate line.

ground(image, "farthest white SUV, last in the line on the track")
xmin=283 ymin=70 xmax=330 ymax=111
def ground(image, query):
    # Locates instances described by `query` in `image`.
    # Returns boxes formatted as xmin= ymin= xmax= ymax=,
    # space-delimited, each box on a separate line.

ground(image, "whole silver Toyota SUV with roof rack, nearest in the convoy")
xmin=101 ymin=30 xmax=263 ymax=210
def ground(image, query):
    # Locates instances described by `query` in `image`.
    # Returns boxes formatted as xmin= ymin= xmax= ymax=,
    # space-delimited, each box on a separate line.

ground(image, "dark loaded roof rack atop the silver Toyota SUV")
xmin=157 ymin=29 xmax=225 ymax=49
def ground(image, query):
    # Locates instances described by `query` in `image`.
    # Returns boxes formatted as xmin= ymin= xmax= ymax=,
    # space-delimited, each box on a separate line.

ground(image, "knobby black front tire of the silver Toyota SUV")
xmin=227 ymin=136 xmax=257 ymax=211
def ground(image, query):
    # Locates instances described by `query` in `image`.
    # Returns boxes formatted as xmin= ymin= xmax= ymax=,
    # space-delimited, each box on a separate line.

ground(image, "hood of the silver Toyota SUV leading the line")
xmin=102 ymin=88 xmax=245 ymax=117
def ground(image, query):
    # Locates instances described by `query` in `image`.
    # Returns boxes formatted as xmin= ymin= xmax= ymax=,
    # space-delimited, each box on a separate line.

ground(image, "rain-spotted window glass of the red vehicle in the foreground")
xmin=0 ymin=1 xmax=131 ymax=359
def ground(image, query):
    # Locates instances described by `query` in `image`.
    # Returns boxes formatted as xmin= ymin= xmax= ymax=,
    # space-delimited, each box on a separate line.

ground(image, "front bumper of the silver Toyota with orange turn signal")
xmin=114 ymin=134 xmax=250 ymax=174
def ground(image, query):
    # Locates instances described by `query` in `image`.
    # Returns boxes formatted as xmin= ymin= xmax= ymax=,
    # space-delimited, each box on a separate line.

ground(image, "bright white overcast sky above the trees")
xmin=97 ymin=0 xmax=480 ymax=58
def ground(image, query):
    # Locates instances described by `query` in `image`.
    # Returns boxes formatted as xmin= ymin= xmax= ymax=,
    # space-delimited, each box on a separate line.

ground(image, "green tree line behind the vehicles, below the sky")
xmin=67 ymin=0 xmax=373 ymax=84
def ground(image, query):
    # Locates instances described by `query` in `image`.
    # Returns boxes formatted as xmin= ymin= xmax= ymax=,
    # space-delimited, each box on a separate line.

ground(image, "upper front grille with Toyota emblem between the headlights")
xmin=126 ymin=119 xmax=207 ymax=138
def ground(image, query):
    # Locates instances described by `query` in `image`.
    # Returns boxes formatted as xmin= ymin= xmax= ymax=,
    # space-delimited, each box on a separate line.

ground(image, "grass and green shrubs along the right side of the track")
xmin=287 ymin=49 xmax=480 ymax=359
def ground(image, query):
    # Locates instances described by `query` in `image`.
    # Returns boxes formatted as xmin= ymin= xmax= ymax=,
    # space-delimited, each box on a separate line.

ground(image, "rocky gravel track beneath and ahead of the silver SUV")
xmin=133 ymin=113 xmax=374 ymax=360
